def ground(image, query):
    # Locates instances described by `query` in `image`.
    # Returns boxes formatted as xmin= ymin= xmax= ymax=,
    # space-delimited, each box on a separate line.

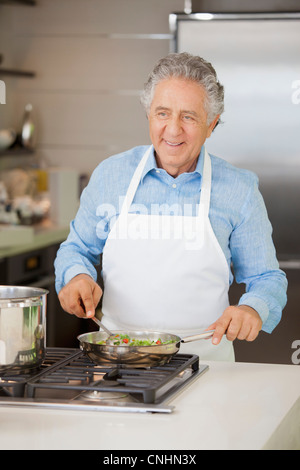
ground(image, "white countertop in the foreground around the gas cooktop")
xmin=0 ymin=362 xmax=300 ymax=455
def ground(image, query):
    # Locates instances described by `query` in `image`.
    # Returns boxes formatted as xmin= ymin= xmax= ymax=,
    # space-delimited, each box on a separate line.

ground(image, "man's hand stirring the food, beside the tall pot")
xmin=58 ymin=274 xmax=102 ymax=318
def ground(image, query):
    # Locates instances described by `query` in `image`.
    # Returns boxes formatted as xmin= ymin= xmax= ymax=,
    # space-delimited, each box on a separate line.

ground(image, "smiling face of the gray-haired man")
xmin=148 ymin=77 xmax=219 ymax=177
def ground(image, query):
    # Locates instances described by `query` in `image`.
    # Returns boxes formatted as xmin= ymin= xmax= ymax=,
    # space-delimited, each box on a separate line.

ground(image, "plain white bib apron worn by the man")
xmin=102 ymin=146 xmax=234 ymax=361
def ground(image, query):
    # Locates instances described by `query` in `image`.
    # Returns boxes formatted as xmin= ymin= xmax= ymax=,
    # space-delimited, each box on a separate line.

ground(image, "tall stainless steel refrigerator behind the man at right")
xmin=170 ymin=10 xmax=300 ymax=364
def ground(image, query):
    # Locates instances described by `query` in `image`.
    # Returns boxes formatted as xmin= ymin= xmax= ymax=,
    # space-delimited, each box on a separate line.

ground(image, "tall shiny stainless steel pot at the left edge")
xmin=0 ymin=286 xmax=48 ymax=373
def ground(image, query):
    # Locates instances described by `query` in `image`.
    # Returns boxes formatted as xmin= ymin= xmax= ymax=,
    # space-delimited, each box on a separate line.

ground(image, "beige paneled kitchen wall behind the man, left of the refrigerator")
xmin=0 ymin=0 xmax=185 ymax=173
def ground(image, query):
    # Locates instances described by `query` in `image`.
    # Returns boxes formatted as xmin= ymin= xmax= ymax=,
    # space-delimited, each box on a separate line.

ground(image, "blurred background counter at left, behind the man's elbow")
xmin=0 ymin=219 xmax=70 ymax=260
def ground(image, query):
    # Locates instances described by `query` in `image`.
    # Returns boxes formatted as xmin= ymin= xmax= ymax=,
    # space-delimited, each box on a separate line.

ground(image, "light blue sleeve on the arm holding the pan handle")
xmin=230 ymin=175 xmax=287 ymax=333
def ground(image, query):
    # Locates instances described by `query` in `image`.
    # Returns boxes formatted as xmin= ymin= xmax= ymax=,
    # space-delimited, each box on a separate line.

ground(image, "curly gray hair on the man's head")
xmin=141 ymin=52 xmax=224 ymax=124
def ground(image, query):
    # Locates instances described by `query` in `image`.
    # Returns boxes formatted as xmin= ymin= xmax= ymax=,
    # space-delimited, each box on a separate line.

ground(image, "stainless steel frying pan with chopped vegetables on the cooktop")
xmin=77 ymin=331 xmax=214 ymax=368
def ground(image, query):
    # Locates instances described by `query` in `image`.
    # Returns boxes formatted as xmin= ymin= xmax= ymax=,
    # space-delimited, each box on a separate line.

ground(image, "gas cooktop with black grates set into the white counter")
xmin=0 ymin=348 xmax=208 ymax=413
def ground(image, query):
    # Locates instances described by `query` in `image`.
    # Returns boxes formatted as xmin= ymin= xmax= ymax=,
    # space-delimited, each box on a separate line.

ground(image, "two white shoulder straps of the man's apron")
xmin=120 ymin=145 xmax=211 ymax=216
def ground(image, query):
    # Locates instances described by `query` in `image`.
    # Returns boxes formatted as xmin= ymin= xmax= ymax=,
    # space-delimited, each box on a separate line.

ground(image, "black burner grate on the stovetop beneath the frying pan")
xmin=27 ymin=350 xmax=199 ymax=403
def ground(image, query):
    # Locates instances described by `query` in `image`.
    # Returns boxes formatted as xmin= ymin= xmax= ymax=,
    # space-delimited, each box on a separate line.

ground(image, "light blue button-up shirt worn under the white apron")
xmin=55 ymin=146 xmax=287 ymax=333
